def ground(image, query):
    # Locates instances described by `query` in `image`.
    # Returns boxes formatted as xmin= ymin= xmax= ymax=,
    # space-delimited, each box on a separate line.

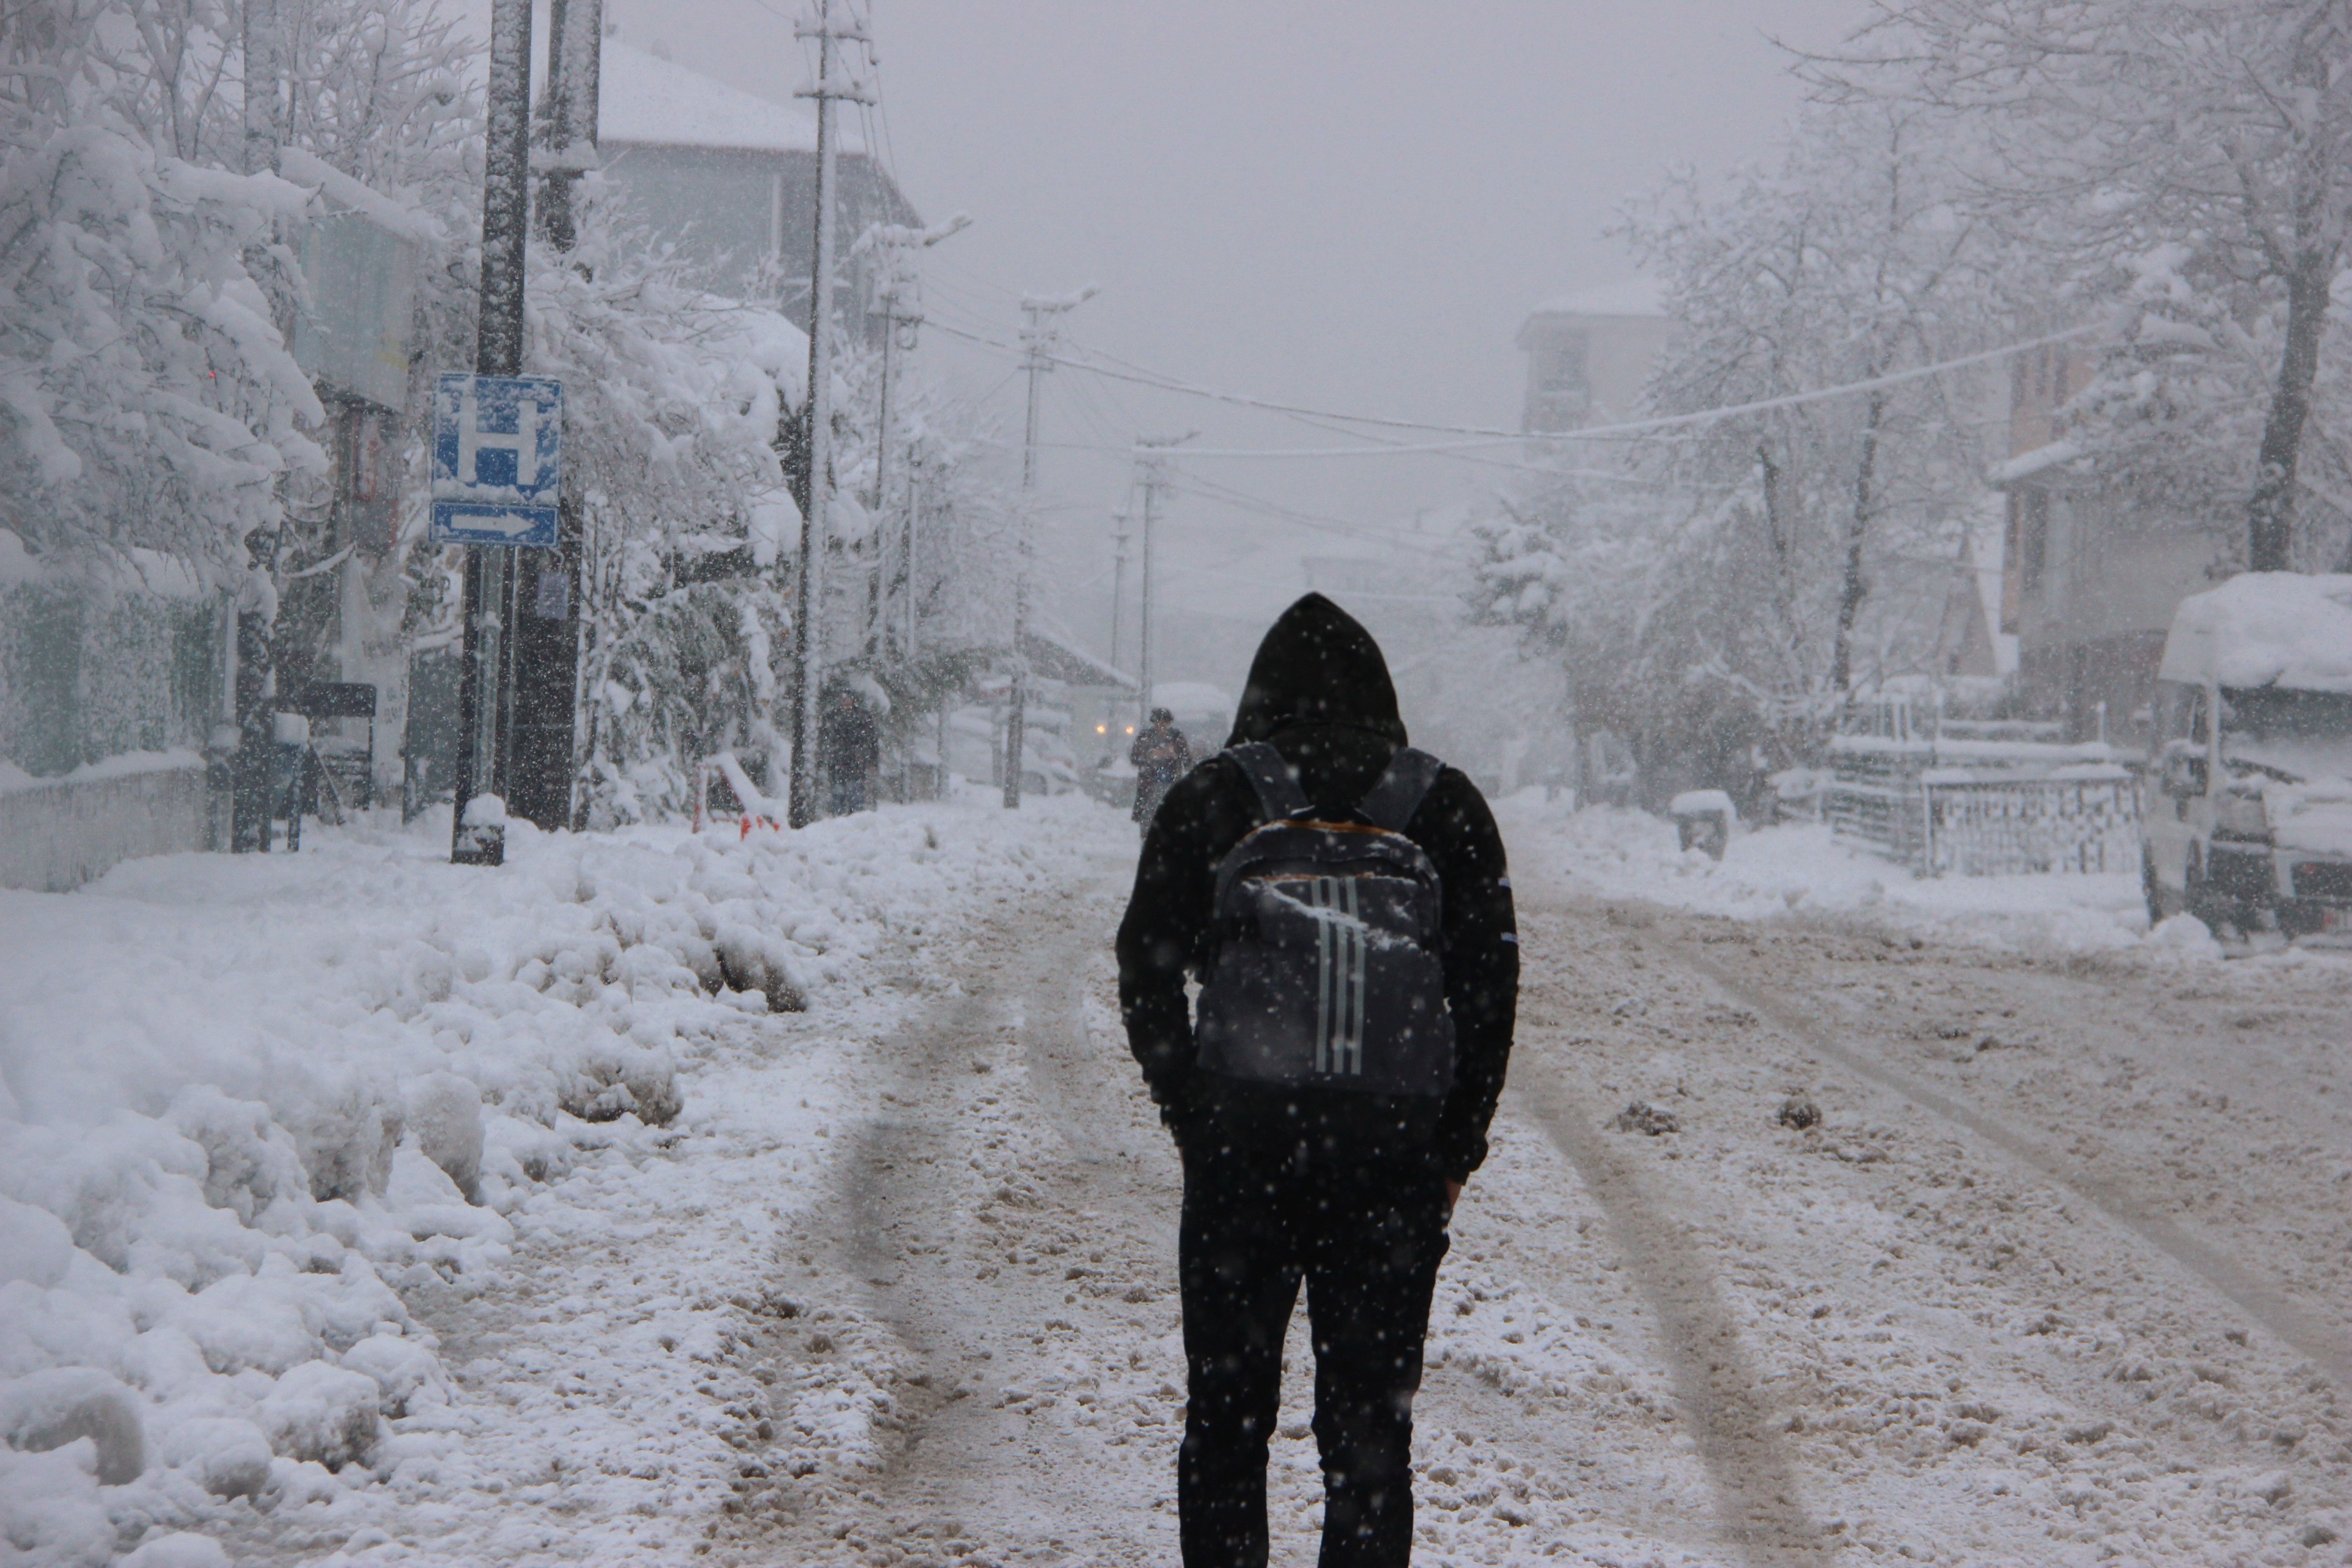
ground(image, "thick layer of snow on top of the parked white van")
xmin=2157 ymin=571 xmax=2352 ymax=691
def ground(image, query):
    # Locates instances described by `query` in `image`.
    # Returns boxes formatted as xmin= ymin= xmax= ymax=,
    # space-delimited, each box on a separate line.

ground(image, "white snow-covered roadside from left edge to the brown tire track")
xmin=0 ymin=799 xmax=1134 ymax=1566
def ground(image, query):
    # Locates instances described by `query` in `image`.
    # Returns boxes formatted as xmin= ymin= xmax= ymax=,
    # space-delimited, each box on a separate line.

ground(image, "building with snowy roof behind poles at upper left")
xmin=598 ymin=38 xmax=920 ymax=332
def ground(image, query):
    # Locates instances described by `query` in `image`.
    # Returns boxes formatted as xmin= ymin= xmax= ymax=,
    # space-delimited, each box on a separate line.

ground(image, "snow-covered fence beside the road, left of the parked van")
xmin=1825 ymin=736 xmax=2140 ymax=877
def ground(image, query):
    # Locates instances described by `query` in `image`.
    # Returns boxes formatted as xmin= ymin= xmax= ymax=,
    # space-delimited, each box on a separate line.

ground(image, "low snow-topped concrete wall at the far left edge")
xmin=0 ymin=757 xmax=212 ymax=893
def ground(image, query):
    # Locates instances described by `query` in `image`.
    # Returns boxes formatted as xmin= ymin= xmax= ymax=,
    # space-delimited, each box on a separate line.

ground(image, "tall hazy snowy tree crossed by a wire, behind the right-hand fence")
xmin=1627 ymin=103 xmax=2004 ymax=710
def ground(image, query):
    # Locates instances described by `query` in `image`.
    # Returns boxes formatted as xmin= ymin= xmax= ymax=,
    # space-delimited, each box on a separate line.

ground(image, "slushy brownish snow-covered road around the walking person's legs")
xmin=725 ymin=841 xmax=2352 ymax=1566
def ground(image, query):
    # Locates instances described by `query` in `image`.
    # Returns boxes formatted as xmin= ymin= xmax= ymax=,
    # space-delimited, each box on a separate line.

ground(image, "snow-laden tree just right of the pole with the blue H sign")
xmin=539 ymin=200 xmax=809 ymax=825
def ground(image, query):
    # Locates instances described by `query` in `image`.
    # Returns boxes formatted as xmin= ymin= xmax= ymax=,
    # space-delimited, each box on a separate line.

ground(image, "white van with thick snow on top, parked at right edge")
xmin=2140 ymin=571 xmax=2352 ymax=938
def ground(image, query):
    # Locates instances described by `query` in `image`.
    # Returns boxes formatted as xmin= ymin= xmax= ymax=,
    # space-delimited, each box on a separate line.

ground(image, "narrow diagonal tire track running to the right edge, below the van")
xmin=1661 ymin=931 xmax=2352 ymax=1392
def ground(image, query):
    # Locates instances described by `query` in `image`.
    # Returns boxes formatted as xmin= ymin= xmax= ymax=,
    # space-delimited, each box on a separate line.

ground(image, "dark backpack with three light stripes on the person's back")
xmin=1197 ymin=740 xmax=1454 ymax=1096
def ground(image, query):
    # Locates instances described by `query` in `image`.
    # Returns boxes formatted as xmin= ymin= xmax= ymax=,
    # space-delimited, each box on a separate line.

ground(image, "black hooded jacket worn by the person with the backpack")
xmin=1120 ymin=593 xmax=1519 ymax=1180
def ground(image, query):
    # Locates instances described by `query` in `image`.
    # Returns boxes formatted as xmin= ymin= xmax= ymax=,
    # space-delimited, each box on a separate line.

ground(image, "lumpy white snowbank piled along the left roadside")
xmin=0 ymin=804 xmax=1124 ymax=1563
